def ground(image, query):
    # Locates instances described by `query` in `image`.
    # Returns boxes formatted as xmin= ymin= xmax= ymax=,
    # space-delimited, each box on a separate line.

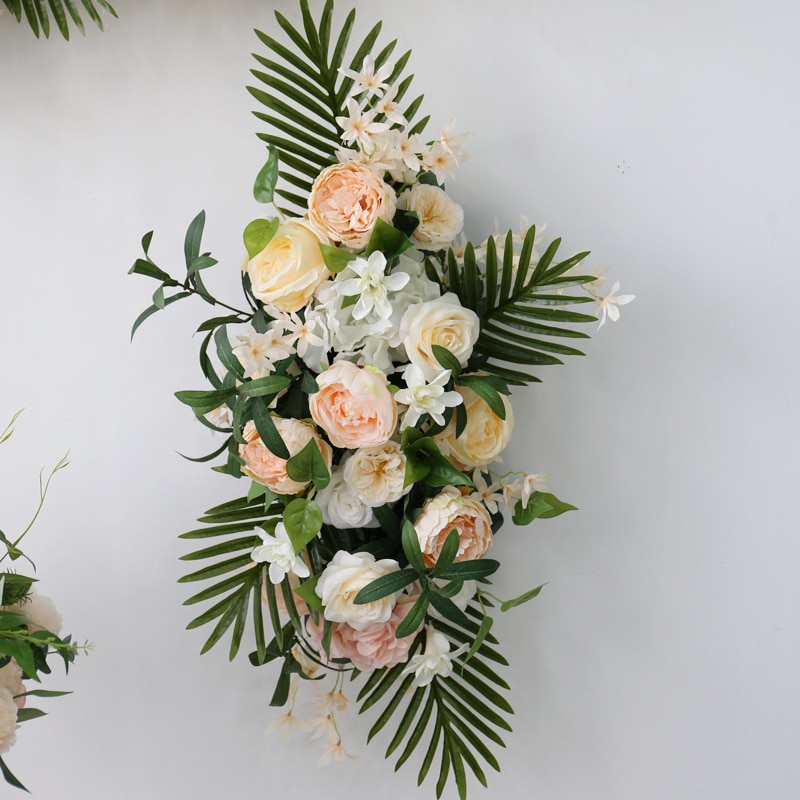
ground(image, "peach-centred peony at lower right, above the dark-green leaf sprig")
xmin=414 ymin=486 xmax=492 ymax=567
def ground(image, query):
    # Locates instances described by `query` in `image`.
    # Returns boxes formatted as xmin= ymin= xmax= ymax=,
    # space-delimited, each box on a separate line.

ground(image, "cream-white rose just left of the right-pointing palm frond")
xmin=400 ymin=292 xmax=480 ymax=382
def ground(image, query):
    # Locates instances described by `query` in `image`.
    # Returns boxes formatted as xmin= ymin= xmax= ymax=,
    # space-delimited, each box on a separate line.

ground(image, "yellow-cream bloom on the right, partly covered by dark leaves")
xmin=434 ymin=386 xmax=514 ymax=467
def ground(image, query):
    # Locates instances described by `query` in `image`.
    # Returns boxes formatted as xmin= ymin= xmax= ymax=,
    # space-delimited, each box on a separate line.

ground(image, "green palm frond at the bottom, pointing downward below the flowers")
xmin=358 ymin=606 xmax=514 ymax=800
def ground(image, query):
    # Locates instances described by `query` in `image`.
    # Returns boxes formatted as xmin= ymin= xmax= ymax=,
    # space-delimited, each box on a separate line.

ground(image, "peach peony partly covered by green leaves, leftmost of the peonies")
xmin=239 ymin=417 xmax=333 ymax=494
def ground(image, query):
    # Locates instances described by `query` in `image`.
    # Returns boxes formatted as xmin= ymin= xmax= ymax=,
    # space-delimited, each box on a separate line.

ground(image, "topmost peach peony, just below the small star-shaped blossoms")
xmin=308 ymin=161 xmax=397 ymax=250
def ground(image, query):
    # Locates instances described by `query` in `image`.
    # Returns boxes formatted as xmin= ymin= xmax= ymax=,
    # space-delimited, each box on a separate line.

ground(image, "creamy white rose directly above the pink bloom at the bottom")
xmin=315 ymin=550 xmax=402 ymax=631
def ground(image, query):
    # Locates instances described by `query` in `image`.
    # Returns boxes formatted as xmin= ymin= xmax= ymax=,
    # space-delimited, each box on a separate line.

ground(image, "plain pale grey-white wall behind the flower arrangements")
xmin=0 ymin=0 xmax=800 ymax=800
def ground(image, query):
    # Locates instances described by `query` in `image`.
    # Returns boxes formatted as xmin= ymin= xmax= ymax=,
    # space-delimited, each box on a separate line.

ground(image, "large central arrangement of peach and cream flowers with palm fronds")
xmin=131 ymin=0 xmax=632 ymax=797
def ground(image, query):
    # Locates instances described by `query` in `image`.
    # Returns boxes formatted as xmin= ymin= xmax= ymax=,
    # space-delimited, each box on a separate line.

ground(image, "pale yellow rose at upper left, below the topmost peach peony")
xmin=245 ymin=219 xmax=330 ymax=311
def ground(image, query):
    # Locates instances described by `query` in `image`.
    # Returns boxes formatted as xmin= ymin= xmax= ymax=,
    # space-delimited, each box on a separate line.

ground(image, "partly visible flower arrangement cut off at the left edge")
xmin=0 ymin=412 xmax=89 ymax=791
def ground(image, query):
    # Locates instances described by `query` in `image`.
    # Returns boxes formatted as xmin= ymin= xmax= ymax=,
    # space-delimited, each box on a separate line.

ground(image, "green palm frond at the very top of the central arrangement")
xmin=247 ymin=0 xmax=427 ymax=215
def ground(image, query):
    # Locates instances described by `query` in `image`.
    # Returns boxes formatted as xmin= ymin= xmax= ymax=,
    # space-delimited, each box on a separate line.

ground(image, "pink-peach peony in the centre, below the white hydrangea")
xmin=308 ymin=361 xmax=397 ymax=449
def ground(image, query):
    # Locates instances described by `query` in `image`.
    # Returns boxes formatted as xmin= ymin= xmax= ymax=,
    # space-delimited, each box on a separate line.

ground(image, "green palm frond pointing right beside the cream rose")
xmin=447 ymin=226 xmax=597 ymax=385
